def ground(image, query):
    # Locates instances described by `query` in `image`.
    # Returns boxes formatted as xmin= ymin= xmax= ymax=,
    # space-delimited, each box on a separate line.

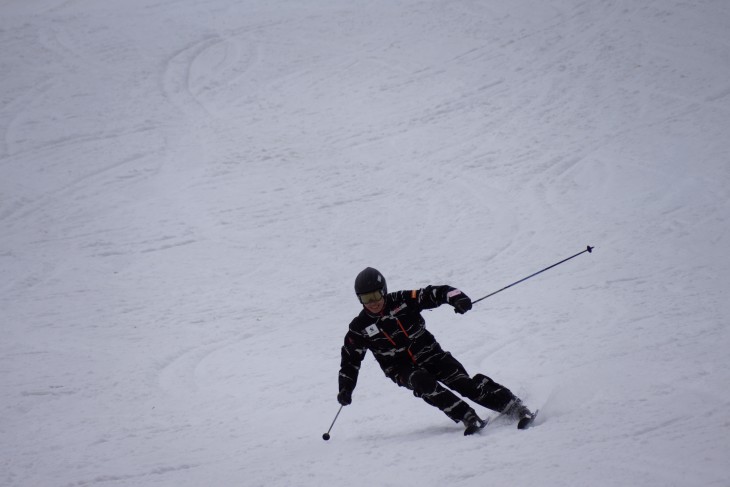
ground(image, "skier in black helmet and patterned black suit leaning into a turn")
xmin=337 ymin=267 xmax=534 ymax=435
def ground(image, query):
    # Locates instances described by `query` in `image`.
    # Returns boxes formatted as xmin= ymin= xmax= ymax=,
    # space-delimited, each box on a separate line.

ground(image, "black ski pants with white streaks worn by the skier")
xmin=393 ymin=351 xmax=515 ymax=422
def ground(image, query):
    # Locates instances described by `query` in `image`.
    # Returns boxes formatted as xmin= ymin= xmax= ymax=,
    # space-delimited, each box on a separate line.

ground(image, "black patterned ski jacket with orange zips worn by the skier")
xmin=339 ymin=286 xmax=461 ymax=392
